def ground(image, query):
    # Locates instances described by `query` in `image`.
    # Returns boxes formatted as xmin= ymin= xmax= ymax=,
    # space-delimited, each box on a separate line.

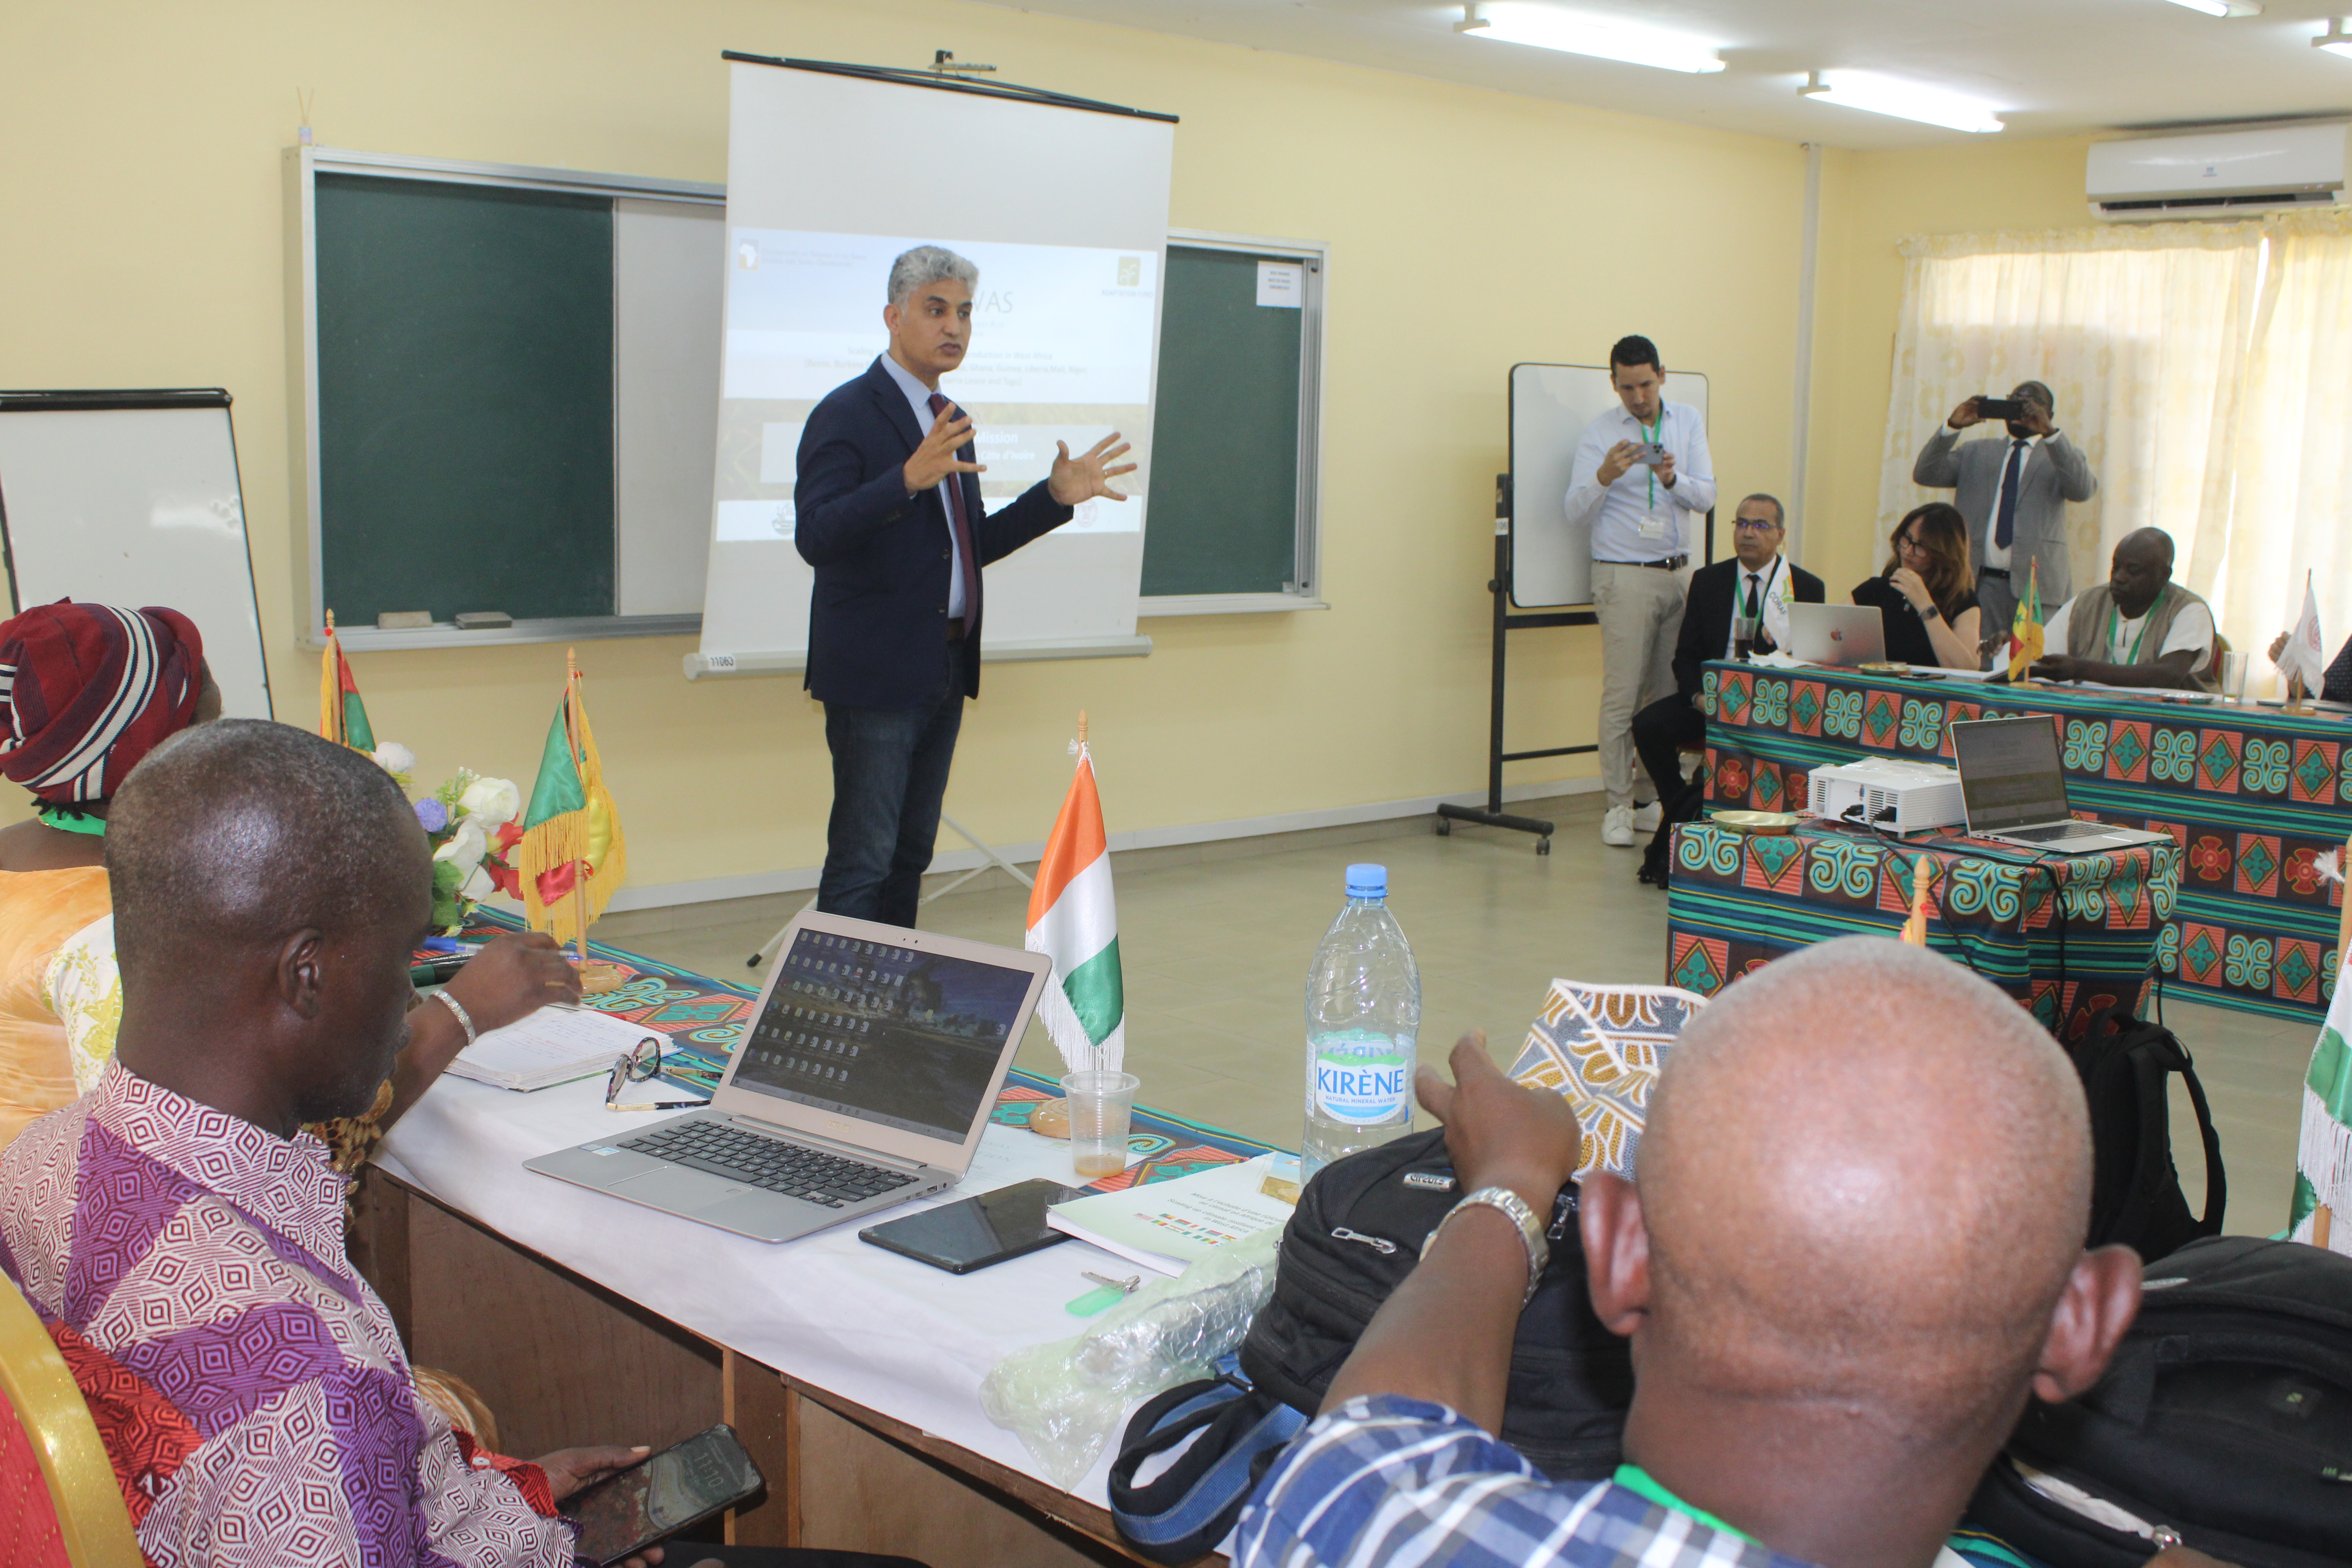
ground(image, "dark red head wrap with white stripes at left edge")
xmin=0 ymin=599 xmax=205 ymax=804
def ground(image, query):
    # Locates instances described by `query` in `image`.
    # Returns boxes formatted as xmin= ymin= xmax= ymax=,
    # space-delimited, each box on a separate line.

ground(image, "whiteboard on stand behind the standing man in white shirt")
xmin=1510 ymin=365 xmax=1708 ymax=609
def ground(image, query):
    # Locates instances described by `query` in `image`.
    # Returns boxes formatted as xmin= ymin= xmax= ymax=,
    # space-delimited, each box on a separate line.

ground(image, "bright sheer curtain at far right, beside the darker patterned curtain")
xmin=2190 ymin=214 xmax=2352 ymax=658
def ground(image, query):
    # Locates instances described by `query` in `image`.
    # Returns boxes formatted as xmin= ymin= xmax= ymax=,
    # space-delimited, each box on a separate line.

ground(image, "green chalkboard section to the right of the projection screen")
xmin=1143 ymin=245 xmax=1305 ymax=595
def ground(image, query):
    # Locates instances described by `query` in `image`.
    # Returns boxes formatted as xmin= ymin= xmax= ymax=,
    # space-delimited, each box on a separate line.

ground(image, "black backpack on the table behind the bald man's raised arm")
xmin=1242 ymin=1129 xmax=1632 ymax=1481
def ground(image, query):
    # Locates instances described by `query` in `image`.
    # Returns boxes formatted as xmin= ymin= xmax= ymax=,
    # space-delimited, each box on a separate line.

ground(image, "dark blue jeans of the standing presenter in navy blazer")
xmin=816 ymin=642 xmax=971 ymax=926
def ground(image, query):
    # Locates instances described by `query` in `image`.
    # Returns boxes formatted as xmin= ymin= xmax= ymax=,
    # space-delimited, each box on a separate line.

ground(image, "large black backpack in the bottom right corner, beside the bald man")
xmin=1969 ymin=1236 xmax=2352 ymax=1568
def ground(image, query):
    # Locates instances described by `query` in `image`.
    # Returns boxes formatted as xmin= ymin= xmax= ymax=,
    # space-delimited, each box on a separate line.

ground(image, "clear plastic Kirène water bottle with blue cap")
xmin=1298 ymin=865 xmax=1421 ymax=1178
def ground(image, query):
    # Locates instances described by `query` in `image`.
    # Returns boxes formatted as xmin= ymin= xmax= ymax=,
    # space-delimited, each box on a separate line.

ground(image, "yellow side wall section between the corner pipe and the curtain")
xmin=1804 ymin=136 xmax=2093 ymax=599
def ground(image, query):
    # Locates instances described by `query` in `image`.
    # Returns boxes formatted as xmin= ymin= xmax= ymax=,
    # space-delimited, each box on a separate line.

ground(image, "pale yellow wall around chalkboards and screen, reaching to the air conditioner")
xmin=0 ymin=0 xmax=2117 ymax=902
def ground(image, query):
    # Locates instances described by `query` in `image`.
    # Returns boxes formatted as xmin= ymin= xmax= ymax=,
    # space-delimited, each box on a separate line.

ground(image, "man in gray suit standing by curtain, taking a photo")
xmin=1912 ymin=381 xmax=2098 ymax=639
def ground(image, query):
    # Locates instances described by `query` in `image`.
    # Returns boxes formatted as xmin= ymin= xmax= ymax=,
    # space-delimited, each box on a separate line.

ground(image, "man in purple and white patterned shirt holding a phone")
xmin=0 ymin=719 xmax=661 ymax=1568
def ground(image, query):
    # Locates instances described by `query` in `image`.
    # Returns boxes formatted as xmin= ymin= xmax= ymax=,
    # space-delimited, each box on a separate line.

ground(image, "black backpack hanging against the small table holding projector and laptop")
xmin=2067 ymin=1006 xmax=2227 ymax=1258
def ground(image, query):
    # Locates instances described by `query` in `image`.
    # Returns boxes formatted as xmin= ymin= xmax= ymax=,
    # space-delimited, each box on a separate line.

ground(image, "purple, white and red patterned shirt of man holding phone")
xmin=0 ymin=1065 xmax=572 ymax=1568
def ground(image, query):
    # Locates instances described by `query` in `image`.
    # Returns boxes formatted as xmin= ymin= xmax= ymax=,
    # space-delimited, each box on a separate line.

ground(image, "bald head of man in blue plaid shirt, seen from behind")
xmin=1639 ymin=938 xmax=2091 ymax=1429
